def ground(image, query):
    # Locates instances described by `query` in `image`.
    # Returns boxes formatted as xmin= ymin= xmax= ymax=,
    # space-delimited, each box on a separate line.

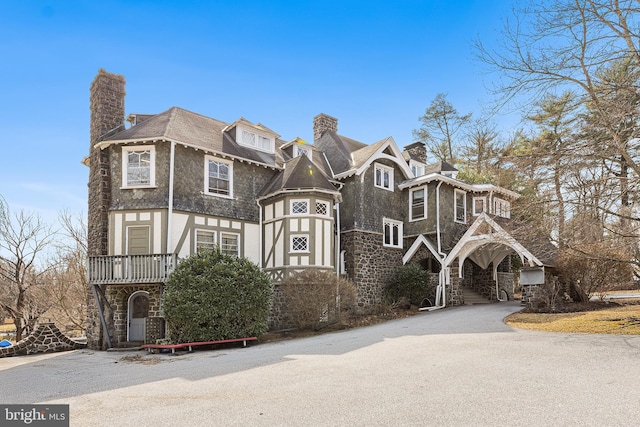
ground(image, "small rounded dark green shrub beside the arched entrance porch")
xmin=385 ymin=264 xmax=435 ymax=306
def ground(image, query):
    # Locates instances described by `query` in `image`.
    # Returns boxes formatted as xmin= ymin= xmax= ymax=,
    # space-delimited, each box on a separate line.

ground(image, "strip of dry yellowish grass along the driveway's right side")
xmin=505 ymin=304 xmax=640 ymax=335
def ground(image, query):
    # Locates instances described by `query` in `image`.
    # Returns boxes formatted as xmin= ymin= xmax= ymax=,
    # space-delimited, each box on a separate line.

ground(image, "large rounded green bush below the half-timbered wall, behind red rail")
xmin=162 ymin=248 xmax=272 ymax=342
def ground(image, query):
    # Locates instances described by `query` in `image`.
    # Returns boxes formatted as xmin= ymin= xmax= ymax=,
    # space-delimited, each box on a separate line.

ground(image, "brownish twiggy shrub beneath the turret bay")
xmin=280 ymin=269 xmax=357 ymax=329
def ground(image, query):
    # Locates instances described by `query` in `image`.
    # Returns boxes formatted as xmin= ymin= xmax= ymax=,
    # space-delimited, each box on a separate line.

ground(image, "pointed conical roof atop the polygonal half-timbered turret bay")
xmin=258 ymin=154 xmax=339 ymax=200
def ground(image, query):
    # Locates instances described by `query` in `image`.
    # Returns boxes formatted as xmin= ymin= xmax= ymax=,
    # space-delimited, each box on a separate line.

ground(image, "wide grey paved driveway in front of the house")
xmin=0 ymin=303 xmax=640 ymax=426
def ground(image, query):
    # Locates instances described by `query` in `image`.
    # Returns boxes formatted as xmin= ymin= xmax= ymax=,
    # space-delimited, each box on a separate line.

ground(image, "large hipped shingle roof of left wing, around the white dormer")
xmin=96 ymin=107 xmax=283 ymax=169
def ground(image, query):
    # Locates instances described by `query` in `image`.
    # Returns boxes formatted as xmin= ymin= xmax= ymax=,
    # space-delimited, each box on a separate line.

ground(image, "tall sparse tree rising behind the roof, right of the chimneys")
xmin=413 ymin=93 xmax=471 ymax=164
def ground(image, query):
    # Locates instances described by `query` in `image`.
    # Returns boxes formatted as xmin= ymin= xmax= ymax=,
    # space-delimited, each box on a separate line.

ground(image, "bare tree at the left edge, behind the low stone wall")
xmin=0 ymin=206 xmax=55 ymax=341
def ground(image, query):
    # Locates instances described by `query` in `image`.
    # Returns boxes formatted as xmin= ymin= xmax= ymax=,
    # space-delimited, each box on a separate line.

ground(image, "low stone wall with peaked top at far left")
xmin=0 ymin=323 xmax=87 ymax=357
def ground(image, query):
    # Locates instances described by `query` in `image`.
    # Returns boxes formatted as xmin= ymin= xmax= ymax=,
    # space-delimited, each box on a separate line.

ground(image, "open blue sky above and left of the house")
xmin=0 ymin=0 xmax=511 ymax=226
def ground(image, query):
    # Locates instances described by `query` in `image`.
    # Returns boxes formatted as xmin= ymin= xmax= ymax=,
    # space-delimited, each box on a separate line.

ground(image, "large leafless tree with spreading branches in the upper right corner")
xmin=476 ymin=0 xmax=640 ymax=175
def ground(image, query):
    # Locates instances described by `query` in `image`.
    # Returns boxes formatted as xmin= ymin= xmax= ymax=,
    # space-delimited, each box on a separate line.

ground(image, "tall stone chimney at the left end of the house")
xmin=87 ymin=69 xmax=125 ymax=256
